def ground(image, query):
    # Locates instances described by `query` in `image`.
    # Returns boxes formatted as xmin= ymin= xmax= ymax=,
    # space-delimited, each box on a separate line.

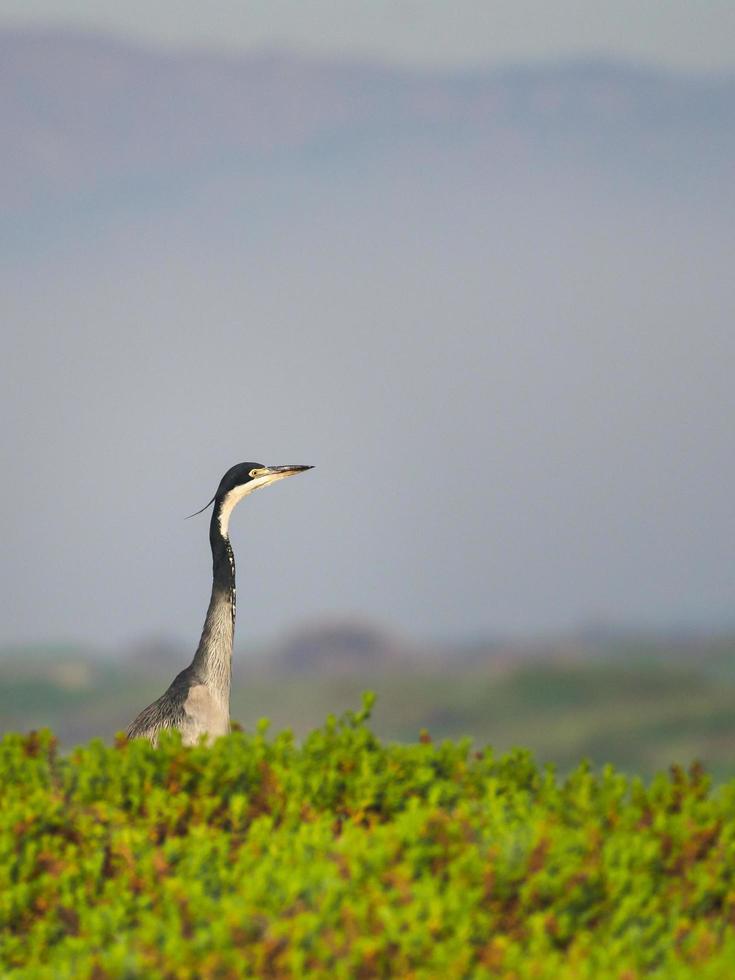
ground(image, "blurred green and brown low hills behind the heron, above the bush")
xmin=0 ymin=623 xmax=735 ymax=777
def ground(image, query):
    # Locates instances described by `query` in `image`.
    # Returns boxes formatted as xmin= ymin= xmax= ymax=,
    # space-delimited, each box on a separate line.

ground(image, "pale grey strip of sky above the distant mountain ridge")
xmin=0 ymin=0 xmax=735 ymax=70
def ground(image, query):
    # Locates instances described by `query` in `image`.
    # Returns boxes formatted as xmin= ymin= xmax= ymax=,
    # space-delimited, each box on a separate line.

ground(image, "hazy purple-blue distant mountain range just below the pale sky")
xmin=0 ymin=30 xmax=735 ymax=216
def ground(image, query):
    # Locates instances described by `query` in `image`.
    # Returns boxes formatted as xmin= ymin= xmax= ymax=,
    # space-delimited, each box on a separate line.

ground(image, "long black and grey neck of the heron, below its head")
xmin=192 ymin=506 xmax=235 ymax=705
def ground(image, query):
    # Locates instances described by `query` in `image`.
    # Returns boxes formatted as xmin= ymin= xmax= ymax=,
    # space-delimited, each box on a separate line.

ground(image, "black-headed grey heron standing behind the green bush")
xmin=128 ymin=463 xmax=313 ymax=745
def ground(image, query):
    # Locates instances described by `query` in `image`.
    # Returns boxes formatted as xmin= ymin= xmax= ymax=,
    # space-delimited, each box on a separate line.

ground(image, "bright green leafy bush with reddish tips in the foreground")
xmin=0 ymin=697 xmax=735 ymax=980
